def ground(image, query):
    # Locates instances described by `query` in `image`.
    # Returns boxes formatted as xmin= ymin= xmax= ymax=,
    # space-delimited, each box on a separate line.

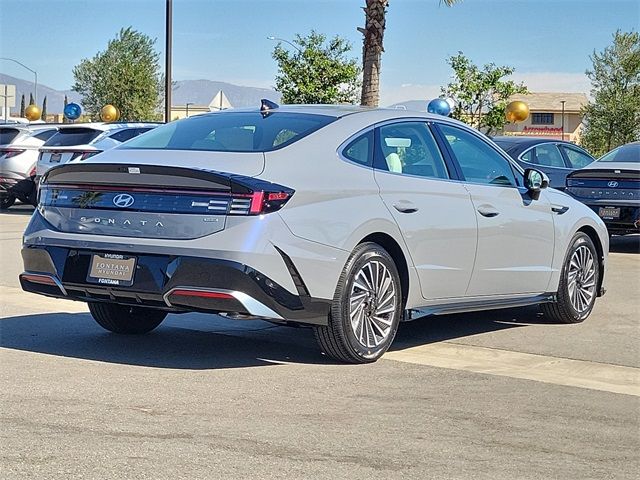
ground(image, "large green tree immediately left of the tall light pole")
xmin=73 ymin=27 xmax=162 ymax=121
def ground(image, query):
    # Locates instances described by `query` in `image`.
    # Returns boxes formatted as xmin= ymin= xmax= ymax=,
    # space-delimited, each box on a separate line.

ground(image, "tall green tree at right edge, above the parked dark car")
xmin=581 ymin=30 xmax=640 ymax=156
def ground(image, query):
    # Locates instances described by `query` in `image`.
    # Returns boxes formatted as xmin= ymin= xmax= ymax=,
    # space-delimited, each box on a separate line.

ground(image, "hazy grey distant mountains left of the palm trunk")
xmin=0 ymin=73 xmax=281 ymax=115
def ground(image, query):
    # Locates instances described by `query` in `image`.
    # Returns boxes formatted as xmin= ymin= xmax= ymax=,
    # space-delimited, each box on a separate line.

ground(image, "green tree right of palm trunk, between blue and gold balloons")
xmin=440 ymin=52 xmax=528 ymax=135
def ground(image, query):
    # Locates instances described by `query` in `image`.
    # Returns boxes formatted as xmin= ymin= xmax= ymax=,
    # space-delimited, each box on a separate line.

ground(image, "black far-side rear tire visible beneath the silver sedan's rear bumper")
xmin=89 ymin=302 xmax=167 ymax=335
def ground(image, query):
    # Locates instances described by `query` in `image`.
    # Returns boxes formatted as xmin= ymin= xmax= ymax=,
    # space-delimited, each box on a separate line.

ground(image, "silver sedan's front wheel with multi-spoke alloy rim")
xmin=540 ymin=232 xmax=600 ymax=323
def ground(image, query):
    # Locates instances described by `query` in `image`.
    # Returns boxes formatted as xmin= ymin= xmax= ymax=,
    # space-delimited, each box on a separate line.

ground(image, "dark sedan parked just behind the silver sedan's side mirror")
xmin=493 ymin=136 xmax=595 ymax=190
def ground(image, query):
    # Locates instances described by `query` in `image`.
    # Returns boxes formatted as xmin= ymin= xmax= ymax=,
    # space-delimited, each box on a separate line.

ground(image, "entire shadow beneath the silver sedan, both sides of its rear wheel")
xmin=0 ymin=308 xmax=544 ymax=370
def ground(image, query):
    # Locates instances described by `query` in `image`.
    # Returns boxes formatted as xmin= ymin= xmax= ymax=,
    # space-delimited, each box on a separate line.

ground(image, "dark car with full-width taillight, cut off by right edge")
xmin=566 ymin=142 xmax=640 ymax=235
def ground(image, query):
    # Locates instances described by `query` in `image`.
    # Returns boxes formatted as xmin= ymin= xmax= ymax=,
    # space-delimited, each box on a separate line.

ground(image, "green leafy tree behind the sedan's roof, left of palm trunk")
xmin=272 ymin=30 xmax=360 ymax=103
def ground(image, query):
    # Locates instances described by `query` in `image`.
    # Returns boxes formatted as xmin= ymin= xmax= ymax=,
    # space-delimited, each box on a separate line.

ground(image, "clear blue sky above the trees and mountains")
xmin=0 ymin=0 xmax=640 ymax=104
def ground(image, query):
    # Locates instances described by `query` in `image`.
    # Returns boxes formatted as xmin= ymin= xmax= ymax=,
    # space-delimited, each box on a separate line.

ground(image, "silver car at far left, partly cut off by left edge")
xmin=0 ymin=123 xmax=58 ymax=210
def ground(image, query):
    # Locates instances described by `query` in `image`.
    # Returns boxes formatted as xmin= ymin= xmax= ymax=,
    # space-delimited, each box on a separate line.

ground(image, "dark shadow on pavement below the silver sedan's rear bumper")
xmin=0 ymin=313 xmax=332 ymax=370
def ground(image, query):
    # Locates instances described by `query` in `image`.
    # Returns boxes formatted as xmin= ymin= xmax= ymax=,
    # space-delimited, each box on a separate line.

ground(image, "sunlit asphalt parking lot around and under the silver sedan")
xmin=0 ymin=207 xmax=640 ymax=479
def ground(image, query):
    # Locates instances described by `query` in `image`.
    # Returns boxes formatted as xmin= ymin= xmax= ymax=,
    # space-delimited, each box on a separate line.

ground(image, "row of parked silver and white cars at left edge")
xmin=0 ymin=123 xmax=157 ymax=210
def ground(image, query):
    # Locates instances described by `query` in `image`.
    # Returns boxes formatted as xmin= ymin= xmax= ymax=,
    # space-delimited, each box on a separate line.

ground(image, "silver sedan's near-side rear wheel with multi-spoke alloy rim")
xmin=314 ymin=243 xmax=404 ymax=363
